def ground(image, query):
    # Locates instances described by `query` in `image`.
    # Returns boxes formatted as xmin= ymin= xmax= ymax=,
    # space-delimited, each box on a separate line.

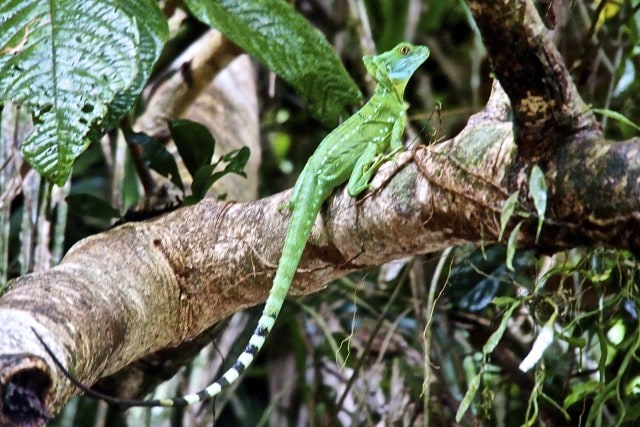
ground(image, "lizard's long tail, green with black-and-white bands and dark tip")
xmin=34 ymin=186 xmax=322 ymax=407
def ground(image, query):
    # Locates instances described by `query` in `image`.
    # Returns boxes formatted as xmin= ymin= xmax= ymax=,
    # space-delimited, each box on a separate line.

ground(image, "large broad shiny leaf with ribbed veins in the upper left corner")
xmin=0 ymin=0 xmax=167 ymax=185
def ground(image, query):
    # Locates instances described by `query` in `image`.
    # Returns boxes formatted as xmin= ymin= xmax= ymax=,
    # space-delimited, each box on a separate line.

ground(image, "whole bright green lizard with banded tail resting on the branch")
xmin=38 ymin=43 xmax=429 ymax=407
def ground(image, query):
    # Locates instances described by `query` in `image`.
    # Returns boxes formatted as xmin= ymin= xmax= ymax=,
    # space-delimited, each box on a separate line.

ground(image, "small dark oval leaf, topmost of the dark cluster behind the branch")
xmin=169 ymin=120 xmax=216 ymax=177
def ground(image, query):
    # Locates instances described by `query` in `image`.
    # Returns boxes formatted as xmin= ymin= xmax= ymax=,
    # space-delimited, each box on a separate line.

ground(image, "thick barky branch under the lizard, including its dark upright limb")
xmin=0 ymin=0 xmax=640 ymax=425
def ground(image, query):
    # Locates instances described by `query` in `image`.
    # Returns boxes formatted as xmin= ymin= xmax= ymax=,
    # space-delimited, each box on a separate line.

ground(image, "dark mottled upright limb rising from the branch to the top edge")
xmin=467 ymin=0 xmax=599 ymax=163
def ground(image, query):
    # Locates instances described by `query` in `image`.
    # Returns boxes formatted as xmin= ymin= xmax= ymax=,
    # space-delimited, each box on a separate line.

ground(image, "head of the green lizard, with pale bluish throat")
xmin=362 ymin=42 xmax=429 ymax=98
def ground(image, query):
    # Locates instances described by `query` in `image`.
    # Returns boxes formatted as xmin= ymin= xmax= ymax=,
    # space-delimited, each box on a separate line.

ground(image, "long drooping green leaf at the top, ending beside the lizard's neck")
xmin=185 ymin=0 xmax=361 ymax=126
